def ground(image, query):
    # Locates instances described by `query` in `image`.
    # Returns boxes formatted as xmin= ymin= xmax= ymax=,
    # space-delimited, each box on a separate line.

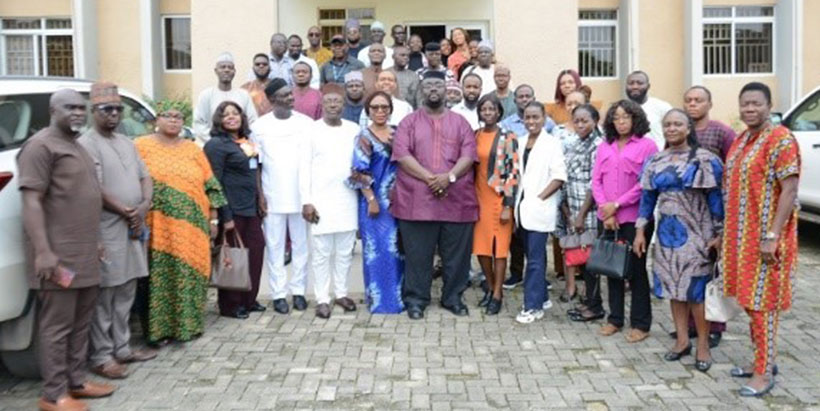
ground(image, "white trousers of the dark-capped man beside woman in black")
xmin=263 ymin=213 xmax=308 ymax=300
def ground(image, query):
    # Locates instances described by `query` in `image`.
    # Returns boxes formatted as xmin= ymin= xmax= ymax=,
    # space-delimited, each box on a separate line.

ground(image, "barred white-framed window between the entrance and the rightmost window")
xmin=578 ymin=10 xmax=618 ymax=77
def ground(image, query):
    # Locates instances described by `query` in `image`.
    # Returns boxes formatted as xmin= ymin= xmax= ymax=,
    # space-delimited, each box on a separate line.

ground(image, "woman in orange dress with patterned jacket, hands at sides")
xmin=473 ymin=94 xmax=518 ymax=315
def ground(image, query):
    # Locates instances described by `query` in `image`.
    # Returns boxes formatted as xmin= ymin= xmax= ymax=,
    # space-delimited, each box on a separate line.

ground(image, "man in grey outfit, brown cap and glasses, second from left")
xmin=78 ymin=82 xmax=157 ymax=379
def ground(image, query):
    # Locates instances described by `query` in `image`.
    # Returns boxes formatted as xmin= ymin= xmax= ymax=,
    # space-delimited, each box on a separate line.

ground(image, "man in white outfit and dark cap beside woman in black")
xmin=251 ymin=77 xmax=313 ymax=314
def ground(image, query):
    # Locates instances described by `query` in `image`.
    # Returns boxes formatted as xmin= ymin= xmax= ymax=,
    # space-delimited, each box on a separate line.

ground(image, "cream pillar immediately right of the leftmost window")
xmin=71 ymin=0 xmax=100 ymax=79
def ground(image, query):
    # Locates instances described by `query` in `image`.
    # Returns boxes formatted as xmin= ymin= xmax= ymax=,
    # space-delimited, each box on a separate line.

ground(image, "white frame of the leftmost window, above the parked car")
xmin=0 ymin=16 xmax=77 ymax=78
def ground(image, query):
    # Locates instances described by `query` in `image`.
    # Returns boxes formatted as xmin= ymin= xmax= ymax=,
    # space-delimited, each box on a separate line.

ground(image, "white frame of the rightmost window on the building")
xmin=700 ymin=5 xmax=777 ymax=78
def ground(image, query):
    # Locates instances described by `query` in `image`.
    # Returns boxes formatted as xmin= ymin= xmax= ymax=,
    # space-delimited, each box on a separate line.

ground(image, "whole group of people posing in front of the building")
xmin=18 ymin=22 xmax=800 ymax=409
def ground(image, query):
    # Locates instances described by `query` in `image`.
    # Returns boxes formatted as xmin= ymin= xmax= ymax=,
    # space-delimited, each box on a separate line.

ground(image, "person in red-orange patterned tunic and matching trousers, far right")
xmin=723 ymin=82 xmax=800 ymax=397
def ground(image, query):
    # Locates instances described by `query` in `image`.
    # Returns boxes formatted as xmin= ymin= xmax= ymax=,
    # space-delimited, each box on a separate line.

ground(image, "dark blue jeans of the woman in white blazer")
xmin=518 ymin=227 xmax=549 ymax=310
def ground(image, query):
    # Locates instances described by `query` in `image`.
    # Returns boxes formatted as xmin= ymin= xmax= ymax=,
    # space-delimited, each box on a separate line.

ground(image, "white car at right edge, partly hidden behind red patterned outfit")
xmin=781 ymin=87 xmax=820 ymax=224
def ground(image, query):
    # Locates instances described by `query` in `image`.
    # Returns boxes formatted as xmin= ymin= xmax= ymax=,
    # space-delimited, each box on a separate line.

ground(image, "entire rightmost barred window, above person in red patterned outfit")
xmin=703 ymin=6 xmax=774 ymax=74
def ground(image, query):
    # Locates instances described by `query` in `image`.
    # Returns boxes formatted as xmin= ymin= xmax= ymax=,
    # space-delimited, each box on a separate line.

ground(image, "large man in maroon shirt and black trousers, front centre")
xmin=390 ymin=70 xmax=478 ymax=320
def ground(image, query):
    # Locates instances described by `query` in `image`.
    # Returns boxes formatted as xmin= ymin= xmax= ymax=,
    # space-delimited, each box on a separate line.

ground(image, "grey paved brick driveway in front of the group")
xmin=0 ymin=225 xmax=820 ymax=411
